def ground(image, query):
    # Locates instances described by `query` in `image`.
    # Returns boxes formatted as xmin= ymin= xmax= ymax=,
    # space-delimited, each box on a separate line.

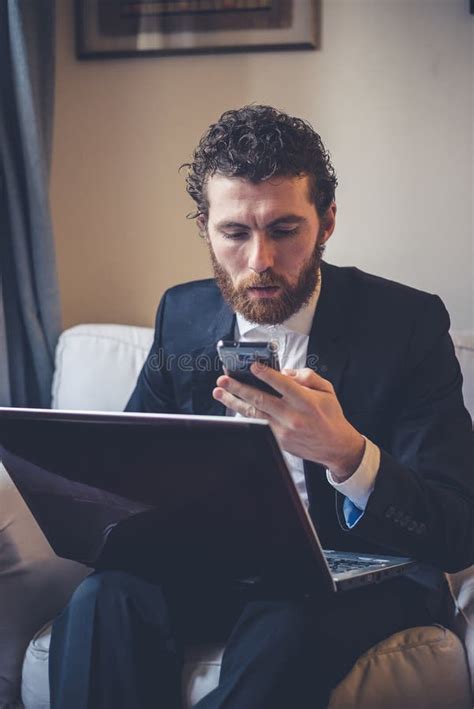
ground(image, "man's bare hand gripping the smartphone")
xmin=213 ymin=363 xmax=365 ymax=482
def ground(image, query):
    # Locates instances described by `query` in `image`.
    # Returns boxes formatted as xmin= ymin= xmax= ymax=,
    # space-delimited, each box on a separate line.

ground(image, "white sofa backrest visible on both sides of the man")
xmin=52 ymin=324 xmax=474 ymax=418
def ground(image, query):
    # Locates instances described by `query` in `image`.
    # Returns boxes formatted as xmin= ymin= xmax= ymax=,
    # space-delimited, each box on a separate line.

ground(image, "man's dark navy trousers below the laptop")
xmin=50 ymin=571 xmax=452 ymax=709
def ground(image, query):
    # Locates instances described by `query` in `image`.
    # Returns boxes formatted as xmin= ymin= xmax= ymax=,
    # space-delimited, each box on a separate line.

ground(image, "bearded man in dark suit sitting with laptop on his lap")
xmin=51 ymin=106 xmax=474 ymax=709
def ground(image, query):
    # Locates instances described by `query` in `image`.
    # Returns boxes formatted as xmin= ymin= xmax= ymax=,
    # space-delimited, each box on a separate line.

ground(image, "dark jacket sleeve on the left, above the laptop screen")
xmin=125 ymin=293 xmax=176 ymax=413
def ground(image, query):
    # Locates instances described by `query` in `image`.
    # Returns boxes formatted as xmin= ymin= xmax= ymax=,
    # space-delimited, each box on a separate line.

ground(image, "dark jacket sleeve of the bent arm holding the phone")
xmin=337 ymin=296 xmax=474 ymax=572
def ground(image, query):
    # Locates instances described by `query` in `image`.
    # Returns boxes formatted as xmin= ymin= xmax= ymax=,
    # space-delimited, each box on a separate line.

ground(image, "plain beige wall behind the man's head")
xmin=51 ymin=0 xmax=474 ymax=328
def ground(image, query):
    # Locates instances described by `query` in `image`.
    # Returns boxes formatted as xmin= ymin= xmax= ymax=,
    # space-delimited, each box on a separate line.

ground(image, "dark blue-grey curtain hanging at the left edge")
xmin=0 ymin=0 xmax=61 ymax=407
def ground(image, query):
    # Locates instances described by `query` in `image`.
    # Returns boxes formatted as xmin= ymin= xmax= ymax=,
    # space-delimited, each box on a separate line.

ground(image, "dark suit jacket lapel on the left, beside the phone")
xmin=191 ymin=300 xmax=235 ymax=416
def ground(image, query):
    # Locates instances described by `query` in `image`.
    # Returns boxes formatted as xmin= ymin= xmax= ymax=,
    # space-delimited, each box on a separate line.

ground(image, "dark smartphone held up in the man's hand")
xmin=217 ymin=340 xmax=282 ymax=398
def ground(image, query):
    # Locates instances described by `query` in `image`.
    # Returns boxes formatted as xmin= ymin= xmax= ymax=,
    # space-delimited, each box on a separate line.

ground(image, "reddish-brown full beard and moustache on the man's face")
xmin=208 ymin=234 xmax=324 ymax=325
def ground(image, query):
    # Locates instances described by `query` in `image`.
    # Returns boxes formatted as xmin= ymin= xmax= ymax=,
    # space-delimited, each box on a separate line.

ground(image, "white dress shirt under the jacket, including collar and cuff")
xmin=227 ymin=278 xmax=380 ymax=526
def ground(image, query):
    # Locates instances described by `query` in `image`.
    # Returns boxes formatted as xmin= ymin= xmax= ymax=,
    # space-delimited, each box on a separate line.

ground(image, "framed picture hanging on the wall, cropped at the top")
xmin=76 ymin=0 xmax=320 ymax=59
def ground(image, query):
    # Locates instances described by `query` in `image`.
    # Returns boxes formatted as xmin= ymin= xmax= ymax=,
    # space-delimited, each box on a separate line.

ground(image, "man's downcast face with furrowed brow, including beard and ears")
xmin=204 ymin=174 xmax=336 ymax=325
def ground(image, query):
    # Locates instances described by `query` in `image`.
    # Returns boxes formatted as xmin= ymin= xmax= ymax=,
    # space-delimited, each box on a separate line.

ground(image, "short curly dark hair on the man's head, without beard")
xmin=182 ymin=105 xmax=337 ymax=219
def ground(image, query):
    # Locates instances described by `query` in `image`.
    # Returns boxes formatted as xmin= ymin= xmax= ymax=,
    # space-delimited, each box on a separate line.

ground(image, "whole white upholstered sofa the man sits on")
xmin=0 ymin=325 xmax=474 ymax=709
